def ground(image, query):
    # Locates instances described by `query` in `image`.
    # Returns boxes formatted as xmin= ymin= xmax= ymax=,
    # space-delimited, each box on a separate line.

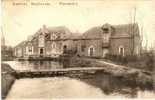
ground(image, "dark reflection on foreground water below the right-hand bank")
xmin=77 ymin=73 xmax=138 ymax=98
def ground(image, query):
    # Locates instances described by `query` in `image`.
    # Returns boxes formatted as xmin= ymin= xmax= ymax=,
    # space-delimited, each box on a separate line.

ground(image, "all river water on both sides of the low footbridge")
xmin=3 ymin=61 xmax=155 ymax=100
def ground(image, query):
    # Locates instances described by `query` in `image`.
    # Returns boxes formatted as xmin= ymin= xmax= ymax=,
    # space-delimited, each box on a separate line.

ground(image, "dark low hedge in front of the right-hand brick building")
xmin=106 ymin=52 xmax=154 ymax=71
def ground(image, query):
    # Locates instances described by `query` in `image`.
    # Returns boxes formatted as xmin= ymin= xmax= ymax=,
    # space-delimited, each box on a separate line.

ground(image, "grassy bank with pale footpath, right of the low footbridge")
xmin=69 ymin=57 xmax=153 ymax=90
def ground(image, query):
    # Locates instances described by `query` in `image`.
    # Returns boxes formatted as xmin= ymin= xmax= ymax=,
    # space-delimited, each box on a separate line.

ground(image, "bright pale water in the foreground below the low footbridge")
xmin=7 ymin=77 xmax=130 ymax=99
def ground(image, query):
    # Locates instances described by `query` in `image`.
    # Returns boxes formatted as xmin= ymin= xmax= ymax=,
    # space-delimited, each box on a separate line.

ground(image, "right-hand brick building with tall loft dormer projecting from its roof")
xmin=78 ymin=24 xmax=141 ymax=57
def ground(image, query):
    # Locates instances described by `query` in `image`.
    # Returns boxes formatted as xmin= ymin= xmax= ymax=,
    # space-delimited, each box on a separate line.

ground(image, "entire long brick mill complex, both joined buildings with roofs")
xmin=15 ymin=23 xmax=141 ymax=57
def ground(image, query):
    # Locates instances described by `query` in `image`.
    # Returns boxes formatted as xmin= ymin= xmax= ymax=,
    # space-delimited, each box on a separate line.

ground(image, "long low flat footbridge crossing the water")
xmin=15 ymin=67 xmax=105 ymax=78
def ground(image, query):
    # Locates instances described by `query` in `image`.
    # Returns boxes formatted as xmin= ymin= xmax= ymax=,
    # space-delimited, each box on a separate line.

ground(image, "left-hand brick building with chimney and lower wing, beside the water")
xmin=14 ymin=26 xmax=76 ymax=57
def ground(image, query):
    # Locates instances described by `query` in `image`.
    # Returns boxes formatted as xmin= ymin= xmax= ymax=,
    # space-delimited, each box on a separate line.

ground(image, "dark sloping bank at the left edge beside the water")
xmin=1 ymin=63 xmax=16 ymax=99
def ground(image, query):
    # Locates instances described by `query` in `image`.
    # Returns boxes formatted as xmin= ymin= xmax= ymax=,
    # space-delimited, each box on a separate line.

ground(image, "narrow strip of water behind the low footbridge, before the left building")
xmin=5 ymin=61 xmax=63 ymax=71
